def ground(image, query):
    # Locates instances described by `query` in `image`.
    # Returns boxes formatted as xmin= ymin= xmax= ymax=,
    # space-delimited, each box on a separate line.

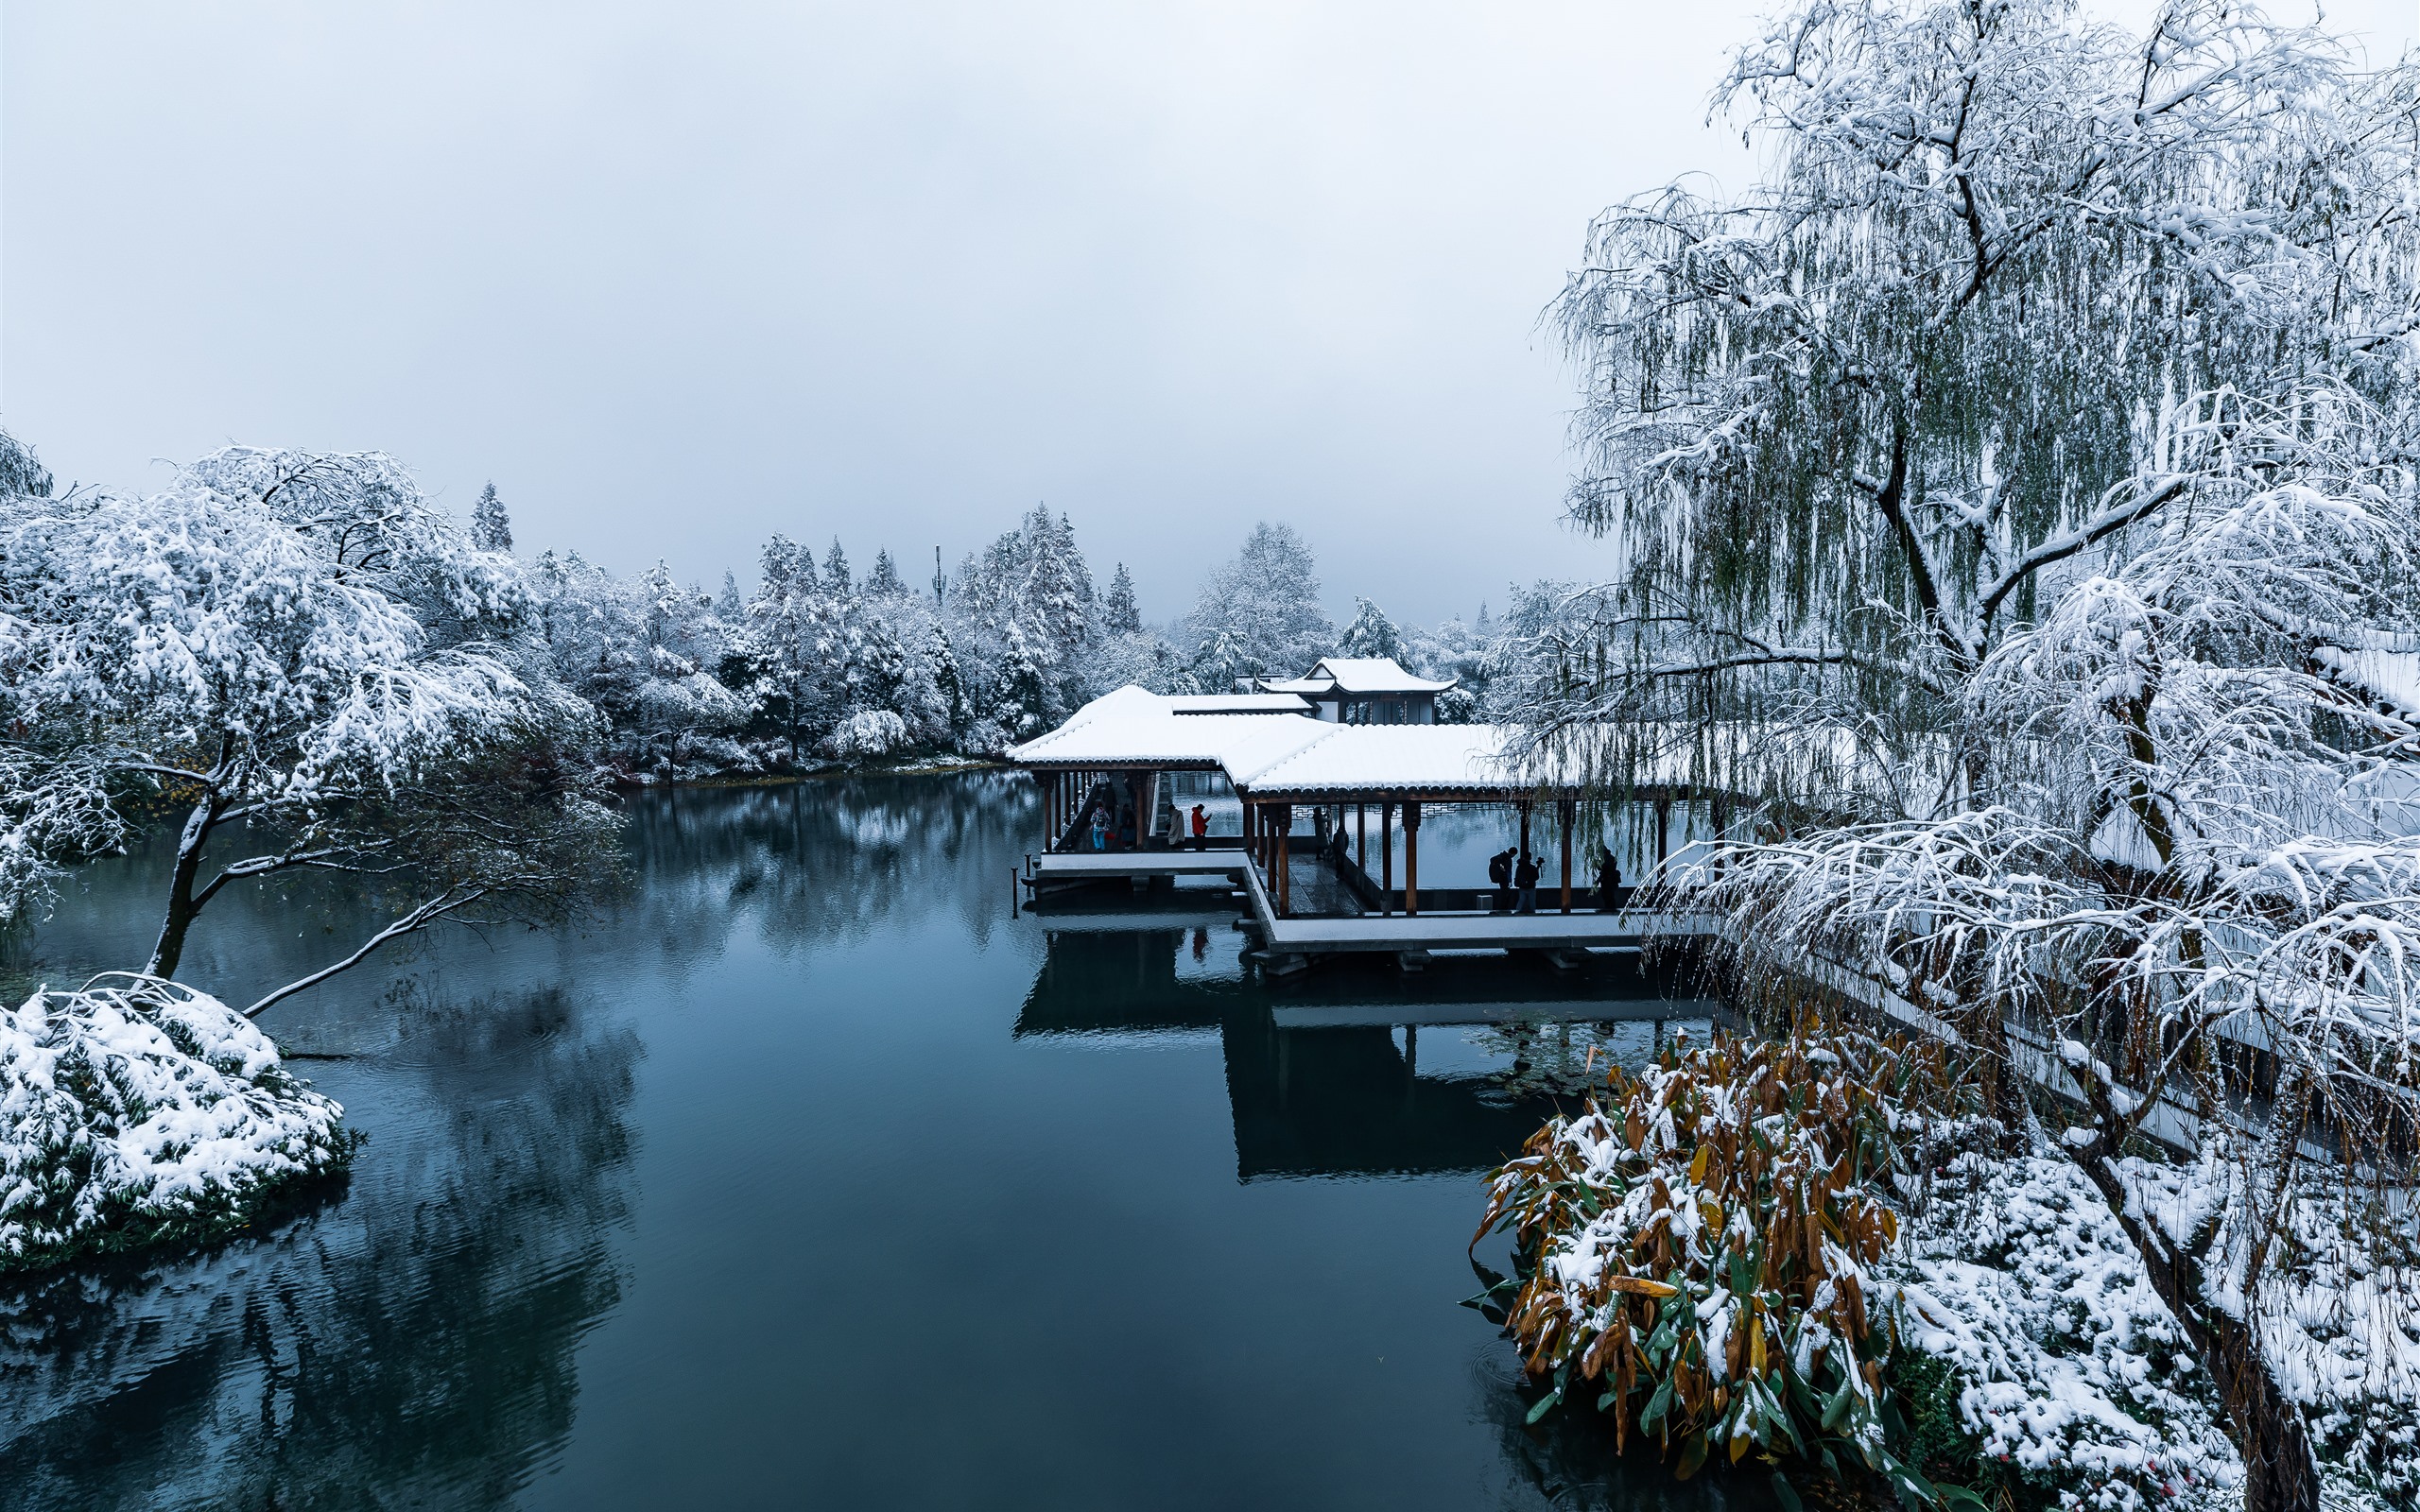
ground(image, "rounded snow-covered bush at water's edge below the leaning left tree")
xmin=0 ymin=975 xmax=354 ymax=1270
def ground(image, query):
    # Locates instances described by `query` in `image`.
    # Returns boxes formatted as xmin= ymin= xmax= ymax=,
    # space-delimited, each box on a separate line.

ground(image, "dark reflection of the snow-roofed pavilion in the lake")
xmin=1016 ymin=910 xmax=1720 ymax=1180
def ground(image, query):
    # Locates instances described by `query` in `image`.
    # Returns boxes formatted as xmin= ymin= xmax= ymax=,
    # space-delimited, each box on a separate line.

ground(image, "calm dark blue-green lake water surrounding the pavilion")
xmin=0 ymin=774 xmax=1764 ymax=1509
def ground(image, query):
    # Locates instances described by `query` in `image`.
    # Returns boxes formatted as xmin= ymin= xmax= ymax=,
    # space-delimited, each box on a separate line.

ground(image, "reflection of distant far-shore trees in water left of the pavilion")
xmin=627 ymin=772 xmax=1038 ymax=949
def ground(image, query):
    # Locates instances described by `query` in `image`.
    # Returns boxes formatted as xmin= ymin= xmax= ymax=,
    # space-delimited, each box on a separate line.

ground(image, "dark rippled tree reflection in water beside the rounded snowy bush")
xmin=0 ymin=992 xmax=639 ymax=1509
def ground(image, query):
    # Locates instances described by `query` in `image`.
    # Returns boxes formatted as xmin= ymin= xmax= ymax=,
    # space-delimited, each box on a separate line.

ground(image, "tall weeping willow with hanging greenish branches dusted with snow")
xmin=1520 ymin=0 xmax=2420 ymax=813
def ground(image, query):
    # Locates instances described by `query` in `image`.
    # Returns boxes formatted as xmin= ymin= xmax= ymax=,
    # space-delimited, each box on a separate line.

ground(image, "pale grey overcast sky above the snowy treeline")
xmin=0 ymin=0 xmax=2420 ymax=622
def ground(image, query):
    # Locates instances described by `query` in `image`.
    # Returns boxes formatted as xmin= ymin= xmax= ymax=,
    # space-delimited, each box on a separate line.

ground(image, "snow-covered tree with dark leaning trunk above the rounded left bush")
xmin=0 ymin=448 xmax=613 ymax=1014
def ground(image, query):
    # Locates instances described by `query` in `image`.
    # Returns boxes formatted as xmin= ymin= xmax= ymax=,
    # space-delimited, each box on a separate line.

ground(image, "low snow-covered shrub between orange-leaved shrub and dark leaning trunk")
xmin=1893 ymin=1154 xmax=2243 ymax=1512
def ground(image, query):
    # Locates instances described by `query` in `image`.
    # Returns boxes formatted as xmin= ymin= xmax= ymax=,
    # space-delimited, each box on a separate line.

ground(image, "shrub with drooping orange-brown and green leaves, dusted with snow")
xmin=1474 ymin=1033 xmax=1987 ymax=1504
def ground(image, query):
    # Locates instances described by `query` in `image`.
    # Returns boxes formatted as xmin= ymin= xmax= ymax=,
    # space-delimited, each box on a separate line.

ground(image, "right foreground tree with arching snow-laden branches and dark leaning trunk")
xmin=1711 ymin=402 xmax=2420 ymax=1507
